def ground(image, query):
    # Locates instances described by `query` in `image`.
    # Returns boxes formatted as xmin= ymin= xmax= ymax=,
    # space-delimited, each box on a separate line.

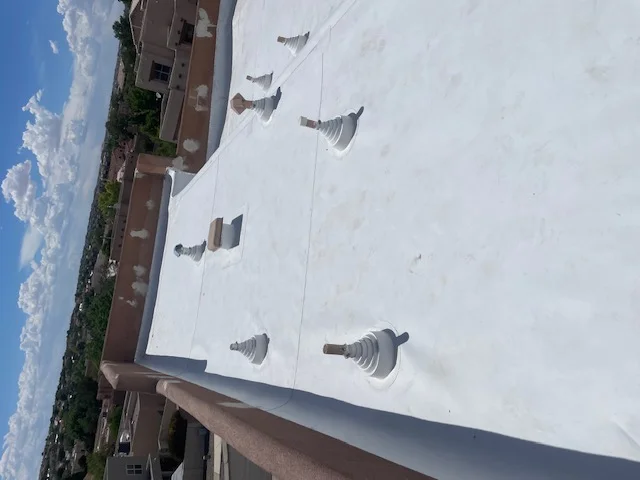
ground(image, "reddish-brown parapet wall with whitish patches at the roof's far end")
xmin=98 ymin=0 xmax=220 ymax=399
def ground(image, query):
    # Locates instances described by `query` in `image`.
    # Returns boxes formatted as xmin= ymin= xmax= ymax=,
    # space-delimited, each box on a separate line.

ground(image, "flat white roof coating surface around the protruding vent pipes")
xmin=147 ymin=0 xmax=640 ymax=472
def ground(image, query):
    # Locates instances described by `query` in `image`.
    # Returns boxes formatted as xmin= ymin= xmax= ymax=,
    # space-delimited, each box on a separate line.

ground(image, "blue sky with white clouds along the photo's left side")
xmin=0 ymin=0 xmax=122 ymax=480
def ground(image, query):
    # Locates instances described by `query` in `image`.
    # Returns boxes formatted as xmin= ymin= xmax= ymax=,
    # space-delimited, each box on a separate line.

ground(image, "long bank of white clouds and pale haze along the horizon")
xmin=0 ymin=0 xmax=122 ymax=480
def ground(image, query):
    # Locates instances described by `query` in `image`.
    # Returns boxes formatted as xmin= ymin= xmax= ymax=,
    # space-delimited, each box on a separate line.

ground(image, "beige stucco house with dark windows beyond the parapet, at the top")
xmin=129 ymin=0 xmax=197 ymax=142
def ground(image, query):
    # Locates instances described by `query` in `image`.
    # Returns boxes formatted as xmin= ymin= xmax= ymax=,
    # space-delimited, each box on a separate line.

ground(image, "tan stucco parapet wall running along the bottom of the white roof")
xmin=158 ymin=381 xmax=430 ymax=480
